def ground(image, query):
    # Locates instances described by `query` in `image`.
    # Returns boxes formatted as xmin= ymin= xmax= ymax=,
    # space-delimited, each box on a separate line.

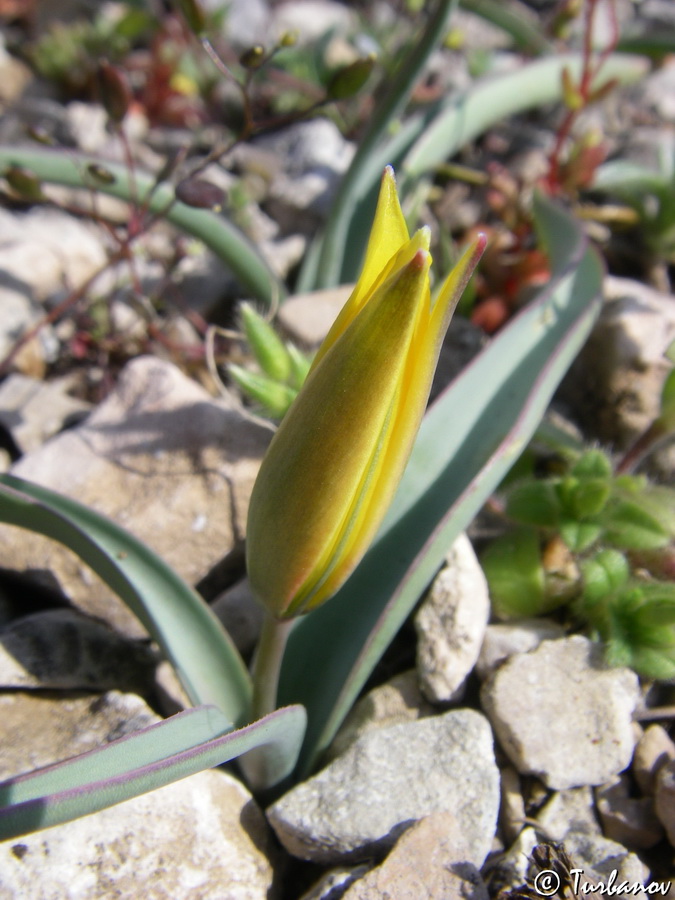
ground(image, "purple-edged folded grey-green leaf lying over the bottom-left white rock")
xmin=0 ymin=706 xmax=306 ymax=840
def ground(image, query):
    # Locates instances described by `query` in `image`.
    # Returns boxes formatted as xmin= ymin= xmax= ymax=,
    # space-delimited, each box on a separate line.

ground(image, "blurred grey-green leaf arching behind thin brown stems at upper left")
xmin=0 ymin=146 xmax=286 ymax=304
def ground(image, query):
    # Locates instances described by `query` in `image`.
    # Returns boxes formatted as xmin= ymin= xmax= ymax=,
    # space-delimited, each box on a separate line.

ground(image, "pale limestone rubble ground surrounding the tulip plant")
xmin=0 ymin=0 xmax=675 ymax=900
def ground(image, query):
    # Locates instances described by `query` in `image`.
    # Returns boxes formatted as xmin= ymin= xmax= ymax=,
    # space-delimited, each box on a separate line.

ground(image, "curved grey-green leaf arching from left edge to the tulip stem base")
xmin=0 ymin=475 xmax=251 ymax=724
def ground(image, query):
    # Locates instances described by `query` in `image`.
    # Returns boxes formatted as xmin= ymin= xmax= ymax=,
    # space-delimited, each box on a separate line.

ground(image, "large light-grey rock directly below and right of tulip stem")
xmin=267 ymin=710 xmax=499 ymax=865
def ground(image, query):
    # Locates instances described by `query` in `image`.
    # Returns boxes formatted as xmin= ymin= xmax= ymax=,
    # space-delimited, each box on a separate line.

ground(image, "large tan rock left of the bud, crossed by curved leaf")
xmin=0 ymin=357 xmax=272 ymax=637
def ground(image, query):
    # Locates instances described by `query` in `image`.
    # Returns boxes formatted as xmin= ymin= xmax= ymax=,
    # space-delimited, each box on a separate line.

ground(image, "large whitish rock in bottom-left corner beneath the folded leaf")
xmin=0 ymin=770 xmax=278 ymax=900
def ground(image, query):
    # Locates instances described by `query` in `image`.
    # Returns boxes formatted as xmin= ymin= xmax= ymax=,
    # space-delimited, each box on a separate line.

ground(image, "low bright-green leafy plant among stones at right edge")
xmin=482 ymin=432 xmax=675 ymax=679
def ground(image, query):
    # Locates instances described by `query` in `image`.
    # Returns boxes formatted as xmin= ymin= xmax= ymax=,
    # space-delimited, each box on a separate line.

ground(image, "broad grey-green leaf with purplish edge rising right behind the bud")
xmin=280 ymin=200 xmax=602 ymax=770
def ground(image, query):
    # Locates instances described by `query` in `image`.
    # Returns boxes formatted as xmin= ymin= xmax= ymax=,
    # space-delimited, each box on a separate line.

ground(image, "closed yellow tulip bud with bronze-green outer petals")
xmin=247 ymin=168 xmax=485 ymax=619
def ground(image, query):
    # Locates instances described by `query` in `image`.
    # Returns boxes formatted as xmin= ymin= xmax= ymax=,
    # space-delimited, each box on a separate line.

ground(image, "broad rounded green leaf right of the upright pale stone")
xmin=481 ymin=528 xmax=545 ymax=619
